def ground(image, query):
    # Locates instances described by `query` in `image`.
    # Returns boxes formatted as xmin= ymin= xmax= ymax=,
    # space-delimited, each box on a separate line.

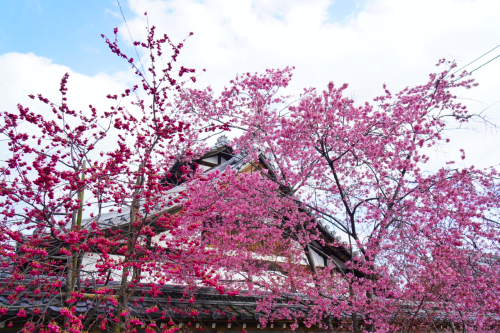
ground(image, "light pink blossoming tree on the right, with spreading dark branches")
xmin=185 ymin=60 xmax=500 ymax=332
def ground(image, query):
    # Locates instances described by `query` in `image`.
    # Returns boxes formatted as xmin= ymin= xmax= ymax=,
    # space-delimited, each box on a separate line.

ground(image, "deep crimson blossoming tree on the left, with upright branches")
xmin=0 ymin=21 xmax=231 ymax=332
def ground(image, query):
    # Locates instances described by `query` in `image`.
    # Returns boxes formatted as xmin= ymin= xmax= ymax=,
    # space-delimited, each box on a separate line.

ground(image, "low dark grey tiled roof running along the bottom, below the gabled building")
xmin=0 ymin=284 xmax=304 ymax=321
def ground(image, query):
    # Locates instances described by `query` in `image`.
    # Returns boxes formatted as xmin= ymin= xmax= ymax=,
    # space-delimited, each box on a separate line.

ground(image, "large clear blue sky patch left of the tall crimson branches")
xmin=0 ymin=0 xmax=139 ymax=75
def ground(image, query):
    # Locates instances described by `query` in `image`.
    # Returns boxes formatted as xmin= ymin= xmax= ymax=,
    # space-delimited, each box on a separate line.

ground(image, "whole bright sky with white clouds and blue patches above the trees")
xmin=0 ymin=0 xmax=500 ymax=166
